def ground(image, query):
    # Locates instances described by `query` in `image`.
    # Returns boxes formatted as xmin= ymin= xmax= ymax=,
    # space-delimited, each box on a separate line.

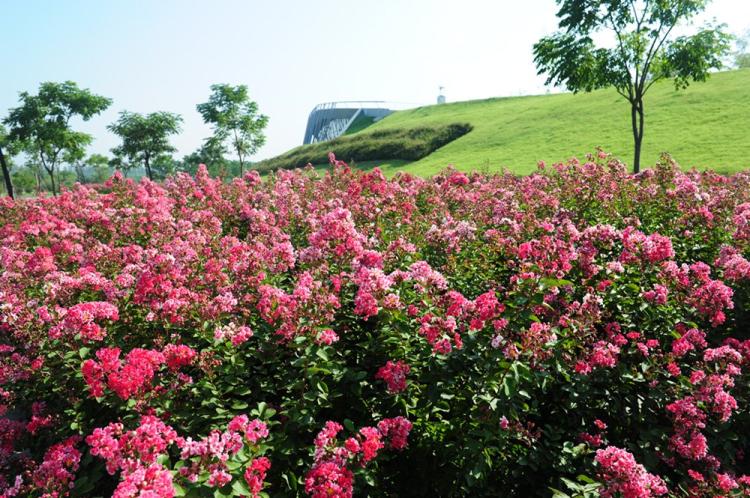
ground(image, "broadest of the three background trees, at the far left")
xmin=4 ymin=81 xmax=112 ymax=195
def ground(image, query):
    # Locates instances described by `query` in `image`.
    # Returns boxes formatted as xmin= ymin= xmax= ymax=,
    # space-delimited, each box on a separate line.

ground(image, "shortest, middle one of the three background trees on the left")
xmin=107 ymin=111 xmax=182 ymax=180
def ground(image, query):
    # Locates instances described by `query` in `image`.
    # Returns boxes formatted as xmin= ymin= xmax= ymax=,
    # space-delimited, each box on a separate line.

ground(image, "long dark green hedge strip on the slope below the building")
xmin=255 ymin=123 xmax=472 ymax=171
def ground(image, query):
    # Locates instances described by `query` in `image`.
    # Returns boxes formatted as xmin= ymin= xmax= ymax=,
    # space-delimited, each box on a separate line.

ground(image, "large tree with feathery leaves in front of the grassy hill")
xmin=534 ymin=0 xmax=731 ymax=173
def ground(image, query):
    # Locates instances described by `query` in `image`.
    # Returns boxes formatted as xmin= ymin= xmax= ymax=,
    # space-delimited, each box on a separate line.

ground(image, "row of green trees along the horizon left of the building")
xmin=0 ymin=81 xmax=268 ymax=197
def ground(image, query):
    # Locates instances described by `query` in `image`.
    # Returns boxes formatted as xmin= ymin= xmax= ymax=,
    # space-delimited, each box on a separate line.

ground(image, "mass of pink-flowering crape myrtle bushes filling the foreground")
xmin=0 ymin=152 xmax=750 ymax=498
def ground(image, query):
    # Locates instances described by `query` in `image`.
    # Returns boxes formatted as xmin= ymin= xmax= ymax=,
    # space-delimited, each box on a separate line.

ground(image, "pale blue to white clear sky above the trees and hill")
xmin=0 ymin=0 xmax=750 ymax=159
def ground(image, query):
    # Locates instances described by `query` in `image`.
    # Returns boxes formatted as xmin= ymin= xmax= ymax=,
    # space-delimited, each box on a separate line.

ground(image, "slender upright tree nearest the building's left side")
xmin=196 ymin=84 xmax=268 ymax=175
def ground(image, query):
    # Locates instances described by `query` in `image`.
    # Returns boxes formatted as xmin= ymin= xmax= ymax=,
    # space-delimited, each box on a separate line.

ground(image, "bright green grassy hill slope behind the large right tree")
xmin=262 ymin=69 xmax=750 ymax=175
